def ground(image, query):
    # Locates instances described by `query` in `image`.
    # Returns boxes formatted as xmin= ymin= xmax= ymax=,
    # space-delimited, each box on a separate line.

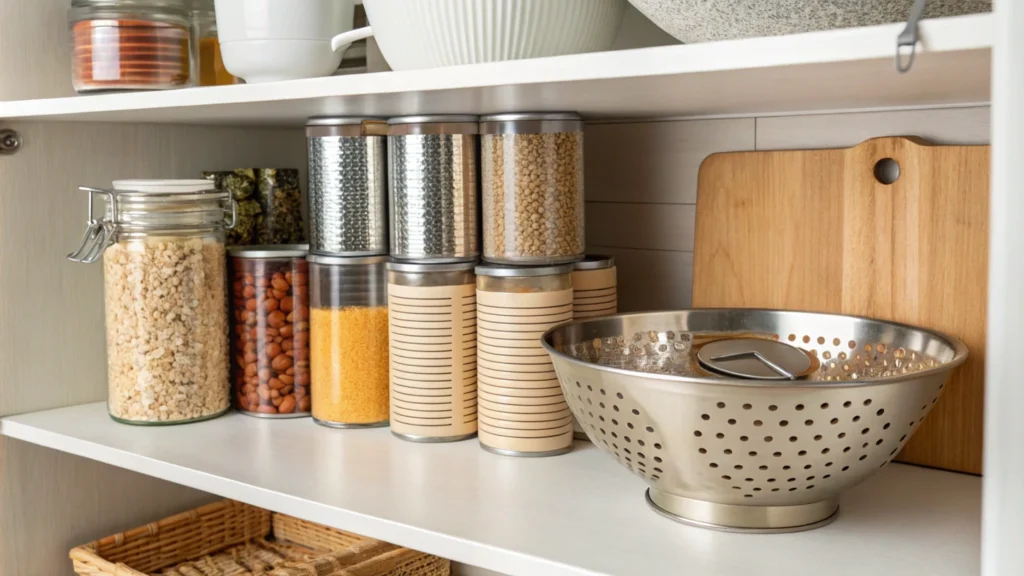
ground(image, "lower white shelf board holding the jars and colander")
xmin=0 ymin=403 xmax=981 ymax=576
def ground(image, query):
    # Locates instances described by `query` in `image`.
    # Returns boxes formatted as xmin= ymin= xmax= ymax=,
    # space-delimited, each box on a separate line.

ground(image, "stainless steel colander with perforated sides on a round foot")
xmin=543 ymin=308 xmax=967 ymax=532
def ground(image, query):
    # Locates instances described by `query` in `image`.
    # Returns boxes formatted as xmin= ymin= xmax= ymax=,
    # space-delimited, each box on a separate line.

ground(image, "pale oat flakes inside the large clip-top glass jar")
xmin=103 ymin=238 xmax=229 ymax=422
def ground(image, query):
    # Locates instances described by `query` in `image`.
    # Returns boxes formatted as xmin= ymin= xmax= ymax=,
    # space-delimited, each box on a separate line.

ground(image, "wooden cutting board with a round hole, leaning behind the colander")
xmin=693 ymin=137 xmax=987 ymax=474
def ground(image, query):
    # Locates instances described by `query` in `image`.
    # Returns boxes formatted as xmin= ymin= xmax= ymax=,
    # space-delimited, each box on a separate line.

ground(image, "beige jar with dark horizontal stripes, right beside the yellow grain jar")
xmin=387 ymin=262 xmax=476 ymax=442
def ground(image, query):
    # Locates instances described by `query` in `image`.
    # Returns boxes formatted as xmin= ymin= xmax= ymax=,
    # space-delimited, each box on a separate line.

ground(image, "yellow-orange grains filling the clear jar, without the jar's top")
xmin=309 ymin=306 xmax=390 ymax=425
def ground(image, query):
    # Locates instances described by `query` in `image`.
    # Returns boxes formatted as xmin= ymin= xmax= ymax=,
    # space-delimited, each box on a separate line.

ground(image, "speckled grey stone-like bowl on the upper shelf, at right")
xmin=630 ymin=0 xmax=992 ymax=43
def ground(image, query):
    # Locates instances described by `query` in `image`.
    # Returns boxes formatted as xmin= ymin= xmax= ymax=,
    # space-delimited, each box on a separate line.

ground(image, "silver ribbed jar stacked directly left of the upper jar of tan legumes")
xmin=387 ymin=116 xmax=480 ymax=262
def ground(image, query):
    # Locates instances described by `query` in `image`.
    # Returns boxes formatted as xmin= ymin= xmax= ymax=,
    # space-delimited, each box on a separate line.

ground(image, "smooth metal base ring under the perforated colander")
xmin=646 ymin=488 xmax=839 ymax=534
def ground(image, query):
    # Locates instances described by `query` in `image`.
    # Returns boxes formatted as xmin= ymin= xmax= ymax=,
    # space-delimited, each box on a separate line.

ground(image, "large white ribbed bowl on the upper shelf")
xmin=331 ymin=0 xmax=626 ymax=70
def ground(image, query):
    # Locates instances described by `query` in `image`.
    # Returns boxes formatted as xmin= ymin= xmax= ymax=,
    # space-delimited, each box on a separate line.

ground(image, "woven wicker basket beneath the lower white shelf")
xmin=70 ymin=500 xmax=451 ymax=576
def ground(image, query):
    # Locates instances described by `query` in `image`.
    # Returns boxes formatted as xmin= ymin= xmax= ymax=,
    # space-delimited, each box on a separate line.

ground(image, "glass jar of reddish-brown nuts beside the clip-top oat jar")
xmin=227 ymin=244 xmax=312 ymax=418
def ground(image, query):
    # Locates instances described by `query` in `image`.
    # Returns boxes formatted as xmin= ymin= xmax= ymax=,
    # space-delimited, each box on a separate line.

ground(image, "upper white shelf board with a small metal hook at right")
xmin=0 ymin=14 xmax=993 ymax=126
